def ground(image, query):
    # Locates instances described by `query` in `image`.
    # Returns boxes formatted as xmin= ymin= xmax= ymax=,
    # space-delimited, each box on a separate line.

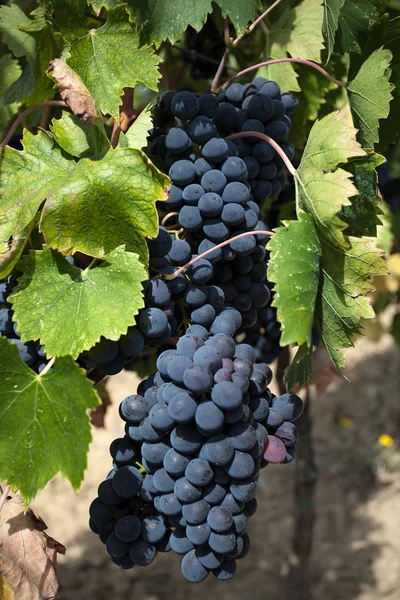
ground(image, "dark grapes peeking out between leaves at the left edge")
xmin=0 ymin=271 xmax=47 ymax=373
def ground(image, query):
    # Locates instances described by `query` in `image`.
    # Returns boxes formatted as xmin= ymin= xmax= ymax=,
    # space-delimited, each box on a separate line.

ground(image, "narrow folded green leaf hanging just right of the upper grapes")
xmin=268 ymin=212 xmax=321 ymax=346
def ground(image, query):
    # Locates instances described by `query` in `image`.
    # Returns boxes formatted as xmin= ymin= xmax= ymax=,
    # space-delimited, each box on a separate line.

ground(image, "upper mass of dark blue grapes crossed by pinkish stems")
xmin=89 ymin=77 xmax=297 ymax=375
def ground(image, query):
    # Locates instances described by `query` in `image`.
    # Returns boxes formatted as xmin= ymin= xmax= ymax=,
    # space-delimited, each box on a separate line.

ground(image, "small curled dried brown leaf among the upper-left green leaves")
xmin=47 ymin=58 xmax=99 ymax=123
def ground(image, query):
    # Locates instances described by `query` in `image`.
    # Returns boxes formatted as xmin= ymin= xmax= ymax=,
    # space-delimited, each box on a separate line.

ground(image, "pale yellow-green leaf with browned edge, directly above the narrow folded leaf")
xmin=295 ymin=113 xmax=365 ymax=247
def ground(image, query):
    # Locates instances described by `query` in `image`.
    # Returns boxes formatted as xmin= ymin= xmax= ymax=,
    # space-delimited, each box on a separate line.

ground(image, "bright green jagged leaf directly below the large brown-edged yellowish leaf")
xmin=9 ymin=247 xmax=147 ymax=358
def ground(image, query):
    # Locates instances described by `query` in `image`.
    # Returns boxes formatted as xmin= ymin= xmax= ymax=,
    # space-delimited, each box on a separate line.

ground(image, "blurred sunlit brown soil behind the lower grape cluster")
xmin=33 ymin=335 xmax=400 ymax=600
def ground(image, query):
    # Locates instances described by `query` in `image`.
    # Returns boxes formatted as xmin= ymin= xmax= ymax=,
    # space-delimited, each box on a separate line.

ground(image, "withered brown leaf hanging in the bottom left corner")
xmin=0 ymin=495 xmax=65 ymax=600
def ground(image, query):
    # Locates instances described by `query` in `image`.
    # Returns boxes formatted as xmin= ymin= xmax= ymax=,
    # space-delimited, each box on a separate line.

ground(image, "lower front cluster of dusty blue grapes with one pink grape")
xmin=90 ymin=325 xmax=302 ymax=582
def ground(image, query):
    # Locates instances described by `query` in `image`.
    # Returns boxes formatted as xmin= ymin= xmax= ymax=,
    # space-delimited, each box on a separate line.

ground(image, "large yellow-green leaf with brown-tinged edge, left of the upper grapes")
xmin=41 ymin=148 xmax=168 ymax=262
